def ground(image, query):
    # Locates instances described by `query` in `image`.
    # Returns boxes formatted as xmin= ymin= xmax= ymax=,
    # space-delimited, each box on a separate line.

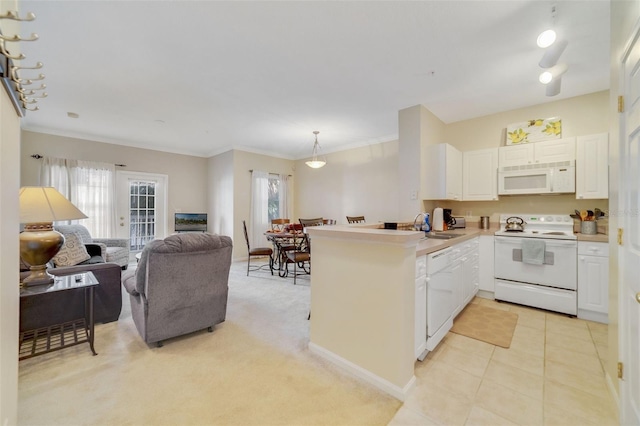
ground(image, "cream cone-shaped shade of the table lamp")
xmin=20 ymin=186 xmax=87 ymax=223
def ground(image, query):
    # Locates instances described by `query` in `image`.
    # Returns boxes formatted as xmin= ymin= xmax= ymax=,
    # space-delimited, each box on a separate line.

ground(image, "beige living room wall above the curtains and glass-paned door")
xmin=20 ymin=131 xmax=208 ymax=234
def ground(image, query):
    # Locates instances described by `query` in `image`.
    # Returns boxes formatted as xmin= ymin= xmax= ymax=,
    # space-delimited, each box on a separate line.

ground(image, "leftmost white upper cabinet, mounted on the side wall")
xmin=422 ymin=143 xmax=462 ymax=200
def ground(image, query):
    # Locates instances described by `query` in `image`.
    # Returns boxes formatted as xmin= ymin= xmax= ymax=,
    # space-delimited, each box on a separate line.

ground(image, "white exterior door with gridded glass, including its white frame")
xmin=116 ymin=171 xmax=167 ymax=252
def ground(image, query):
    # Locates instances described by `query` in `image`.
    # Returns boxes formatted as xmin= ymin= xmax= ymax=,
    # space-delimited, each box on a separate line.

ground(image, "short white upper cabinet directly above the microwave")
xmin=498 ymin=138 xmax=576 ymax=167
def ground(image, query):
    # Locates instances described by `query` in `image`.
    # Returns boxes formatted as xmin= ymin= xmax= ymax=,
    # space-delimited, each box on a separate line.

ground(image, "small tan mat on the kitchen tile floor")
xmin=451 ymin=303 xmax=518 ymax=348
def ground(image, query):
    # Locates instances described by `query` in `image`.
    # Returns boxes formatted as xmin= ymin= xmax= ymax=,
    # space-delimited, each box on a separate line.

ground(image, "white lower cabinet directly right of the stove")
xmin=578 ymin=241 xmax=609 ymax=324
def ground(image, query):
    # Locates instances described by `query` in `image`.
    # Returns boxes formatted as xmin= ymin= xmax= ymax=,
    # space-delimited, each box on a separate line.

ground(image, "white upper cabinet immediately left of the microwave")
xmin=462 ymin=148 xmax=498 ymax=201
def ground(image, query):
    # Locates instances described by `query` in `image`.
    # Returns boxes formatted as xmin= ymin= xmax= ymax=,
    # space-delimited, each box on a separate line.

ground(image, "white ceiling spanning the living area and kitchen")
xmin=12 ymin=0 xmax=610 ymax=159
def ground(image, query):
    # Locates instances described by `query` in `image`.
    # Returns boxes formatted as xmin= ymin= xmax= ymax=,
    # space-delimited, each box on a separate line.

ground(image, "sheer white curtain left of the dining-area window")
xmin=247 ymin=170 xmax=270 ymax=247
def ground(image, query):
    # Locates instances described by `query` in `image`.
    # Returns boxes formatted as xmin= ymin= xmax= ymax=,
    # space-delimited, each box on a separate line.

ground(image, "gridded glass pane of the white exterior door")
xmin=129 ymin=180 xmax=156 ymax=251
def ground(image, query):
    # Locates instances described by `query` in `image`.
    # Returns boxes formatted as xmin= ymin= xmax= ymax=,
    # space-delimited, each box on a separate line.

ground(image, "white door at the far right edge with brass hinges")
xmin=618 ymin=25 xmax=640 ymax=425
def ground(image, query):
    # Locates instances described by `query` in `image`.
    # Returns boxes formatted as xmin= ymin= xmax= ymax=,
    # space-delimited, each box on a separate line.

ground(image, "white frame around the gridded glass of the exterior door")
xmin=116 ymin=170 xmax=169 ymax=243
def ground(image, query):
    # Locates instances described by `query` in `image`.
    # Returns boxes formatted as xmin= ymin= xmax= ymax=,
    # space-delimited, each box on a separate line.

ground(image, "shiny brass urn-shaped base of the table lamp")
xmin=20 ymin=222 xmax=64 ymax=286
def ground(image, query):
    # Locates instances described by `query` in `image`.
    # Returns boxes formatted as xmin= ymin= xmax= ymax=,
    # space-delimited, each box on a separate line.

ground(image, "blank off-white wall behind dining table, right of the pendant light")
xmin=294 ymin=141 xmax=399 ymax=223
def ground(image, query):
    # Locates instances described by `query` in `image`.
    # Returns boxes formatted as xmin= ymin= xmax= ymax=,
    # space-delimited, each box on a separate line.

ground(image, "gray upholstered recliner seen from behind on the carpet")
xmin=122 ymin=233 xmax=232 ymax=346
